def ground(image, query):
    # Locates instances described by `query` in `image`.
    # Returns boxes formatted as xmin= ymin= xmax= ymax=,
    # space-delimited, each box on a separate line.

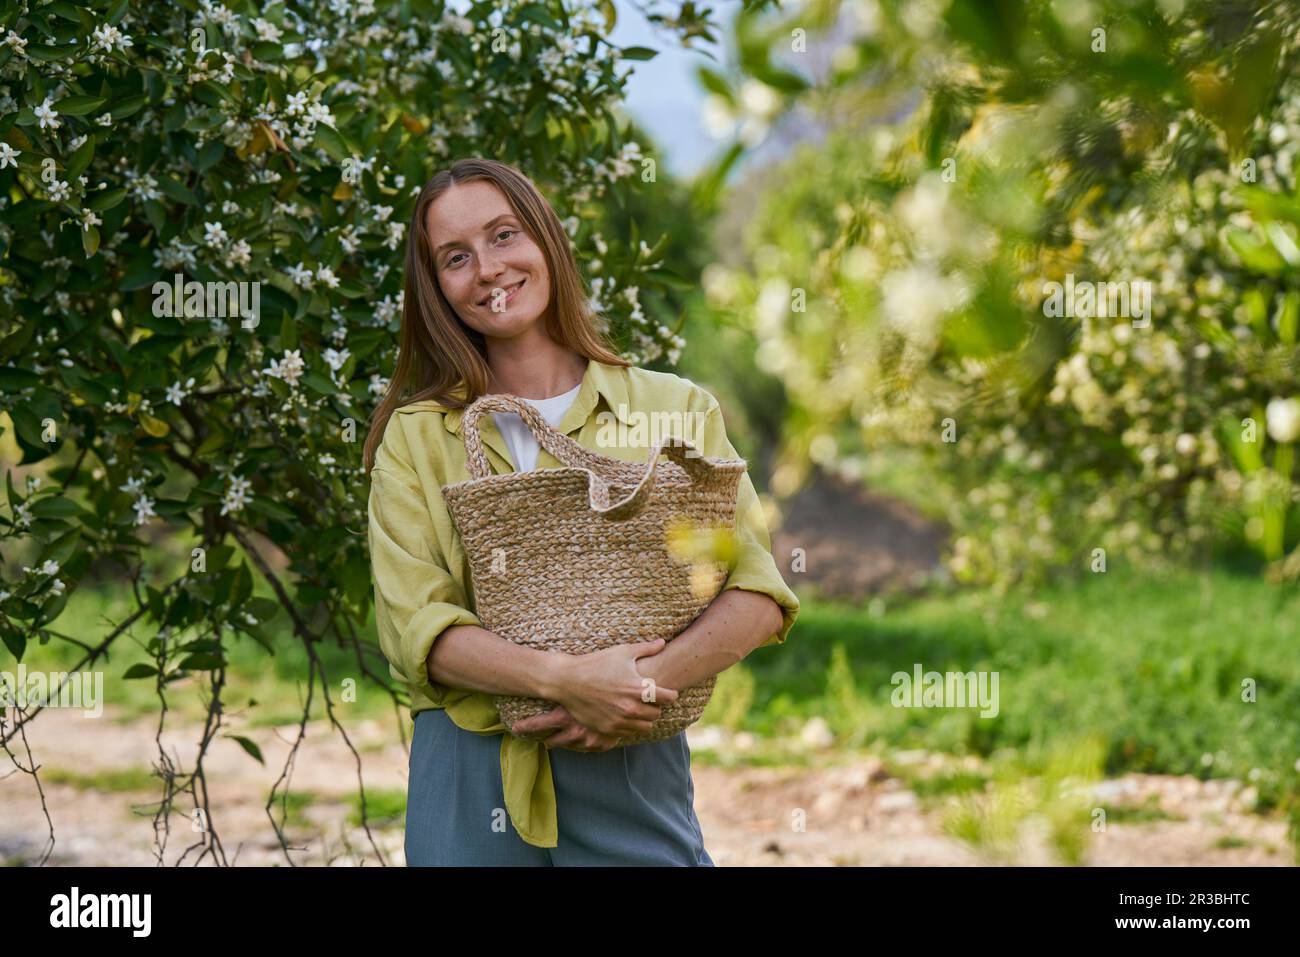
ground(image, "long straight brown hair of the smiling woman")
xmin=364 ymin=157 xmax=631 ymax=475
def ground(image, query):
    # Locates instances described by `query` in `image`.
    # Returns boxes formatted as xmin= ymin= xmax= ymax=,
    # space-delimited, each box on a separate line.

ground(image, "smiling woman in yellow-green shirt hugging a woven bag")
xmin=365 ymin=159 xmax=798 ymax=866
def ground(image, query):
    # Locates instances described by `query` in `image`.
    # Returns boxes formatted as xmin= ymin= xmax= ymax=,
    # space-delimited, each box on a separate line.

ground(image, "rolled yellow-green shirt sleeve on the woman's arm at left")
xmin=369 ymin=420 xmax=482 ymax=707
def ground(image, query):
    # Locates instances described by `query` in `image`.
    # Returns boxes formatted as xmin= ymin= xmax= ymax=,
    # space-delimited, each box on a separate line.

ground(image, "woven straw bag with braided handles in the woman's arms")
xmin=442 ymin=394 xmax=746 ymax=745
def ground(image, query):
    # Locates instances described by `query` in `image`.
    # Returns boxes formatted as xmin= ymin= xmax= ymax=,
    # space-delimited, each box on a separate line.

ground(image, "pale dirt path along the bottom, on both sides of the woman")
xmin=0 ymin=710 xmax=1292 ymax=866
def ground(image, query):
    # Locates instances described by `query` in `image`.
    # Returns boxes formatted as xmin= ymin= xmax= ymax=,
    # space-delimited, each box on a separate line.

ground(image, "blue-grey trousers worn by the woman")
xmin=406 ymin=709 xmax=714 ymax=867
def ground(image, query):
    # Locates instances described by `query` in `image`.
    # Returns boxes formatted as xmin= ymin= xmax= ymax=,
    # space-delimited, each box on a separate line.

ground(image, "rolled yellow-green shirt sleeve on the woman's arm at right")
xmin=702 ymin=393 xmax=800 ymax=648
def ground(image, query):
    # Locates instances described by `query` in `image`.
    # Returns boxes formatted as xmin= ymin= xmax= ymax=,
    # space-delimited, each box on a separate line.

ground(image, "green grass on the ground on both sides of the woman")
xmin=12 ymin=553 xmax=1300 ymax=810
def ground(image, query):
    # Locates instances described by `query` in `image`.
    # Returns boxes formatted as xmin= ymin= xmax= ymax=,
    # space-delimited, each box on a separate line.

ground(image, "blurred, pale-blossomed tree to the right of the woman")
xmin=706 ymin=0 xmax=1300 ymax=584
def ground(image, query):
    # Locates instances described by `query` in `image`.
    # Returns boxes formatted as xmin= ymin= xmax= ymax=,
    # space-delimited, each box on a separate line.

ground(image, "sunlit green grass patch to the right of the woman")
xmin=740 ymin=564 xmax=1300 ymax=807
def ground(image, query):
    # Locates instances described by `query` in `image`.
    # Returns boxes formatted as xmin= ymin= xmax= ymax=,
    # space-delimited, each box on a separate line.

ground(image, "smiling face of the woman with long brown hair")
xmin=426 ymin=179 xmax=551 ymax=338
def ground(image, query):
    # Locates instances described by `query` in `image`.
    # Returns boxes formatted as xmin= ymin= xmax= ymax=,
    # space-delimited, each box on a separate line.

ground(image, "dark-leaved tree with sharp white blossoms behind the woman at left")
xmin=0 ymin=0 xmax=743 ymax=861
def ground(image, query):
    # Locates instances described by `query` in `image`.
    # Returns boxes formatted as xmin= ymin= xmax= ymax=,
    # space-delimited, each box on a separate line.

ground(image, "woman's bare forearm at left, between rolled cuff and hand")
xmin=425 ymin=624 xmax=559 ymax=698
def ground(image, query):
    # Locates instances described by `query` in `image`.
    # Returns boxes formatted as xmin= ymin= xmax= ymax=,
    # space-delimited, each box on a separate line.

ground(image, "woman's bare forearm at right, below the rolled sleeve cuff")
xmin=637 ymin=588 xmax=784 ymax=690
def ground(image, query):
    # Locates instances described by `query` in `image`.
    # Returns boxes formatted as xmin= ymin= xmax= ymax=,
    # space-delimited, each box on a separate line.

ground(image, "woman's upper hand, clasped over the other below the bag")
xmin=554 ymin=638 xmax=677 ymax=737
